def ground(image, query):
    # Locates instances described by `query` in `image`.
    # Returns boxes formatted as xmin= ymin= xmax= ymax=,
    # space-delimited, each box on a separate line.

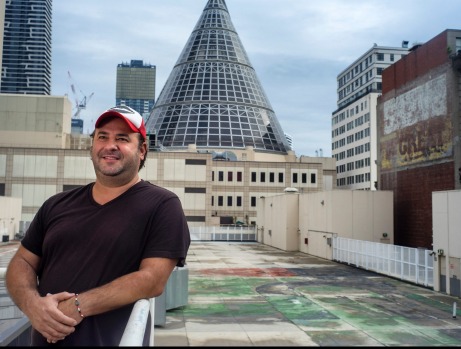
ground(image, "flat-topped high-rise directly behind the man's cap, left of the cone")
xmin=115 ymin=59 xmax=156 ymax=119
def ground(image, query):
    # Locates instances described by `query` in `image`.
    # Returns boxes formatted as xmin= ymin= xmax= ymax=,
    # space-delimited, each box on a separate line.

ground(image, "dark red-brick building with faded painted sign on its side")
xmin=377 ymin=29 xmax=461 ymax=249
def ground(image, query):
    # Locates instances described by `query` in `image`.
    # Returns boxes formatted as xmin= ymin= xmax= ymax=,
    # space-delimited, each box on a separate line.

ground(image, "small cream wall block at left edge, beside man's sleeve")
xmin=0 ymin=196 xmax=22 ymax=240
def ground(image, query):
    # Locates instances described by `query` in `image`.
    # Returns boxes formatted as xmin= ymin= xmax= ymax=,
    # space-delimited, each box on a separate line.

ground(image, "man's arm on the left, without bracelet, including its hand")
xmin=5 ymin=246 xmax=77 ymax=341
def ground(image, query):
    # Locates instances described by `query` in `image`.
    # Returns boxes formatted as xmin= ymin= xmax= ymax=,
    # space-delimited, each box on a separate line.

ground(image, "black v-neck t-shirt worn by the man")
xmin=21 ymin=181 xmax=190 ymax=346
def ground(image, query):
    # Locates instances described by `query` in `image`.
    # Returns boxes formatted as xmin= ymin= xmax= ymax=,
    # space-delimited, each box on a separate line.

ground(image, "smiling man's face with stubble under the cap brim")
xmin=91 ymin=118 xmax=146 ymax=182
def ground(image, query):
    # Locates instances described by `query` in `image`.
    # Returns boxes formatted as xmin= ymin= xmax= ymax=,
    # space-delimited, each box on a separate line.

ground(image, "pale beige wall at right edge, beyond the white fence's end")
xmin=432 ymin=190 xmax=461 ymax=296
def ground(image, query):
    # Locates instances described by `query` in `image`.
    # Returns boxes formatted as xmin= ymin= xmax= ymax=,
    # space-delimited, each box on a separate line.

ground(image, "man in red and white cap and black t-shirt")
xmin=6 ymin=107 xmax=190 ymax=346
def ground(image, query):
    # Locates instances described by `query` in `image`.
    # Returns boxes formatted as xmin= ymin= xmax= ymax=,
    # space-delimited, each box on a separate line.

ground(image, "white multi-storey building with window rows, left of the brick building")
xmin=331 ymin=41 xmax=409 ymax=190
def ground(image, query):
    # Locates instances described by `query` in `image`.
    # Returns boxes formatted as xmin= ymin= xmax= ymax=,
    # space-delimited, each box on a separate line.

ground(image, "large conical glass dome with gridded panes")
xmin=146 ymin=0 xmax=291 ymax=154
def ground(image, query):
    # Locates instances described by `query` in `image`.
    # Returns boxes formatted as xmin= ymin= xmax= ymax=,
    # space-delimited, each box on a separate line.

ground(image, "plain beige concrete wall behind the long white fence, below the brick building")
xmin=257 ymin=190 xmax=394 ymax=259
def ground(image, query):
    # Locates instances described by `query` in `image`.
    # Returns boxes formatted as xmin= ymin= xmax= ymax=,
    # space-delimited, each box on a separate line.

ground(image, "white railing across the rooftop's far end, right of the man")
xmin=189 ymin=225 xmax=257 ymax=241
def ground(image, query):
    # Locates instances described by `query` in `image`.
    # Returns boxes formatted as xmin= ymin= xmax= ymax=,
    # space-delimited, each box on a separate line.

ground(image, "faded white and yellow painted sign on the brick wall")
xmin=381 ymin=74 xmax=453 ymax=170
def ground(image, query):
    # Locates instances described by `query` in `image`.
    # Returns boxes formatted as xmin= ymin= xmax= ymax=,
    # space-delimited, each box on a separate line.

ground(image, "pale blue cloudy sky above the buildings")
xmin=52 ymin=0 xmax=461 ymax=157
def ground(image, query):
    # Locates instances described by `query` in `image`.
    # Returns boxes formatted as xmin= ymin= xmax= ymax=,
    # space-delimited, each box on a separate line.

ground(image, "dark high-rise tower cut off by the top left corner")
xmin=0 ymin=0 xmax=52 ymax=95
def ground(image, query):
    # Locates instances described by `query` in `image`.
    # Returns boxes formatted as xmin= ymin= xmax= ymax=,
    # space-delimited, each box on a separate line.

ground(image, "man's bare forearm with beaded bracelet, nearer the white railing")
xmin=59 ymin=258 xmax=178 ymax=320
